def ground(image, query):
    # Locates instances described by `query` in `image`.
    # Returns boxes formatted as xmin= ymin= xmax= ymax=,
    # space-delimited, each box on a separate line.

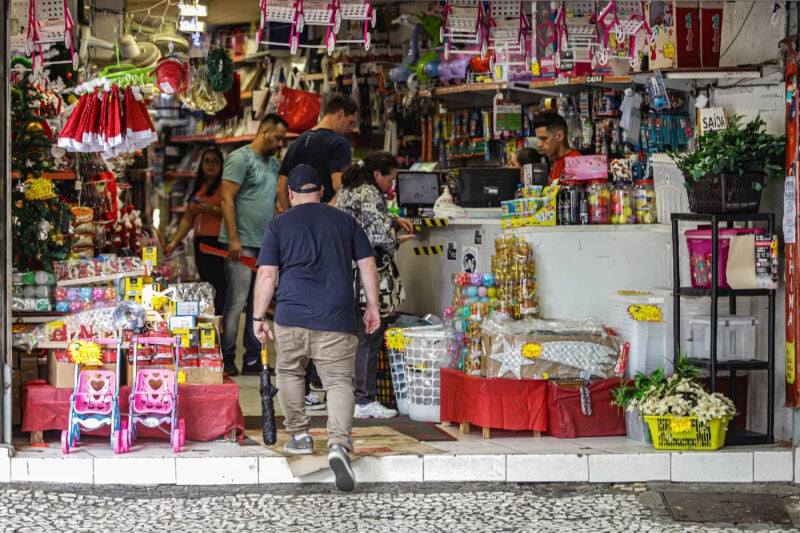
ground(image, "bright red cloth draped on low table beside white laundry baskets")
xmin=441 ymin=368 xmax=547 ymax=431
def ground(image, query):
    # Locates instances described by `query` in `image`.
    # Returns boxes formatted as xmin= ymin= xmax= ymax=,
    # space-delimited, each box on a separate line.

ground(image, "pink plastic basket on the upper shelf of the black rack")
xmin=684 ymin=228 xmax=764 ymax=289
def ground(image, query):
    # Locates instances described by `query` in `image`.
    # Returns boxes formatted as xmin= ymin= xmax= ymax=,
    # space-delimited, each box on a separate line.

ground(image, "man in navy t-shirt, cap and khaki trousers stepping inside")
xmin=253 ymin=165 xmax=381 ymax=491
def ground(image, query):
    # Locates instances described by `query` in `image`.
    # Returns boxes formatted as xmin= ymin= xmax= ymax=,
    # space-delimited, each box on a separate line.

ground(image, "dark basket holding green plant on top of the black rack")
xmin=686 ymin=173 xmax=764 ymax=213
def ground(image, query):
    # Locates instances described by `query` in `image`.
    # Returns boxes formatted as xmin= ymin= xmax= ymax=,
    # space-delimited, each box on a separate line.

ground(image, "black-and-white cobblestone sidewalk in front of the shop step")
xmin=0 ymin=483 xmax=798 ymax=533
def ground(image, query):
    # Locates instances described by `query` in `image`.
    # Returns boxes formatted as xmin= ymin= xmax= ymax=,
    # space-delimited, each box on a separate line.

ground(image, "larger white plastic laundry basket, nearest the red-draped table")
xmin=403 ymin=326 xmax=450 ymax=422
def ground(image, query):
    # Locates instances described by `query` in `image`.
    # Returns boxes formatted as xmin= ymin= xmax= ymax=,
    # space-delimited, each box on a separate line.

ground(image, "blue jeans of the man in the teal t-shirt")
xmin=220 ymin=247 xmax=261 ymax=365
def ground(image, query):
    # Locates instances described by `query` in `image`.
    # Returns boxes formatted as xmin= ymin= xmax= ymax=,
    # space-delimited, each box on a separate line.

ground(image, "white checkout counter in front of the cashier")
xmin=397 ymin=218 xmax=672 ymax=318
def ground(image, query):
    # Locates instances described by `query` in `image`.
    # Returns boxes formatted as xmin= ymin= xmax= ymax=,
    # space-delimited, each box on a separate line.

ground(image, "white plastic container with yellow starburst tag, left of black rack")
xmin=605 ymin=294 xmax=673 ymax=377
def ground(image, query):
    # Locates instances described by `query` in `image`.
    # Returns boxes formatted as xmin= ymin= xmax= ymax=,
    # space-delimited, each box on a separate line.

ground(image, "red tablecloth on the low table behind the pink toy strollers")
xmin=22 ymin=376 xmax=244 ymax=441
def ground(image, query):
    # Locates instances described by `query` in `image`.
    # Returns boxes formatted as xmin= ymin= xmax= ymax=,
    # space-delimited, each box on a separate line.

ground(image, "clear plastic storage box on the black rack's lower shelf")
xmin=691 ymin=315 xmax=758 ymax=361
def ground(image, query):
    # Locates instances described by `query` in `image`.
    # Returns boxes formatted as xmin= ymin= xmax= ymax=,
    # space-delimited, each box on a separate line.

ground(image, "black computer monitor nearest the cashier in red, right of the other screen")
xmin=458 ymin=168 xmax=521 ymax=207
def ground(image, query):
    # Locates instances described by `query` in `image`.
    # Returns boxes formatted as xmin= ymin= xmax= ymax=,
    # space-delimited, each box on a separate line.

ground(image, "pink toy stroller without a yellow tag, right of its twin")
xmin=122 ymin=337 xmax=186 ymax=453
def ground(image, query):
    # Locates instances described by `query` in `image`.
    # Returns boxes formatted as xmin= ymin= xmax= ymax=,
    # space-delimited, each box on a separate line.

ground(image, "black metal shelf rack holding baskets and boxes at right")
xmin=672 ymin=213 xmax=775 ymax=445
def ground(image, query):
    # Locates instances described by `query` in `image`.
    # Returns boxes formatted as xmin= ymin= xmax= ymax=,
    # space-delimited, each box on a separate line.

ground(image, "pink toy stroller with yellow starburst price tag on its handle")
xmin=61 ymin=339 xmax=124 ymax=454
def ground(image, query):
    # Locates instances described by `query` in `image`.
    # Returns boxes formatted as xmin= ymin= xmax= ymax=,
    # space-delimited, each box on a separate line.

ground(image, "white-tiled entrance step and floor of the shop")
xmin=6 ymin=326 xmax=800 ymax=485
